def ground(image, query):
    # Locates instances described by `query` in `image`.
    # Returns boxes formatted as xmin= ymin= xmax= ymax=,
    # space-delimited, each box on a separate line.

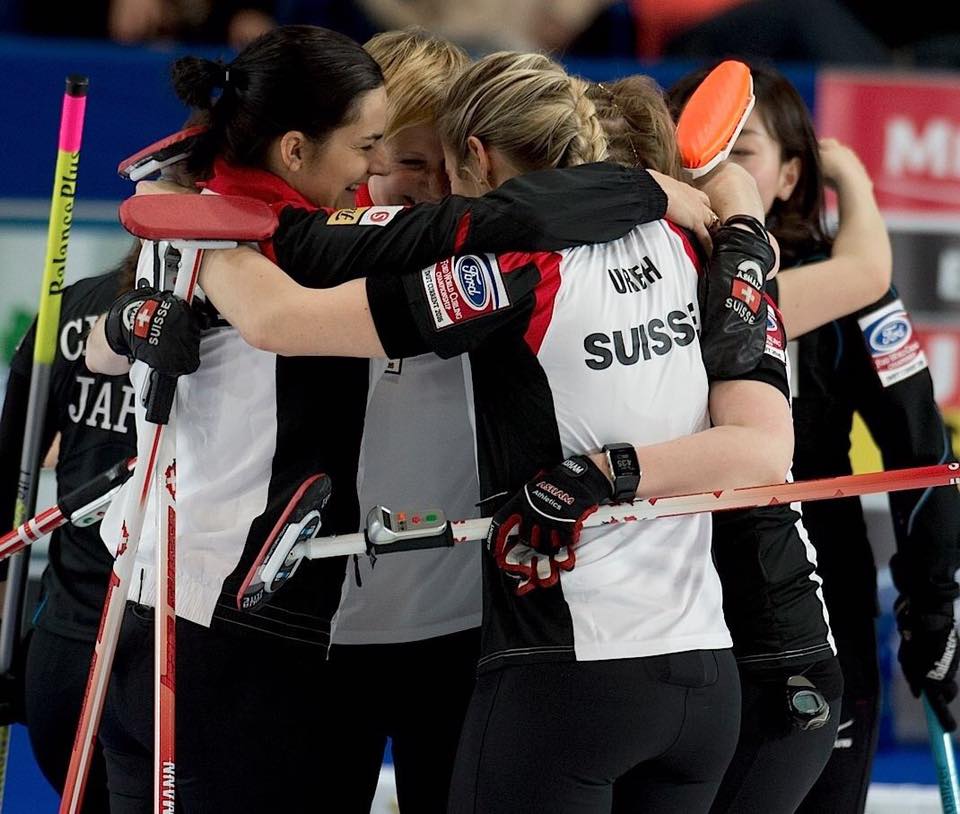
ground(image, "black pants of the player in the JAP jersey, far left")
xmin=25 ymin=628 xmax=109 ymax=814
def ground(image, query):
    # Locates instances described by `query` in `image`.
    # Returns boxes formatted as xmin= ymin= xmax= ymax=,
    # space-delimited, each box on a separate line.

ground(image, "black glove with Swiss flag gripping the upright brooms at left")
xmin=104 ymin=288 xmax=200 ymax=376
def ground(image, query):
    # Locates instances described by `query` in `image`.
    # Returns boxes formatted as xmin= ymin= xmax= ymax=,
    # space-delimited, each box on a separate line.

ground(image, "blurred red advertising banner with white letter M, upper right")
xmin=816 ymin=70 xmax=960 ymax=218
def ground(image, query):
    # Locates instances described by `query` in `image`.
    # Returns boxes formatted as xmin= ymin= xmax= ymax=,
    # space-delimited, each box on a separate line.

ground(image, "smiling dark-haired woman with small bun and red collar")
xmin=87 ymin=26 xmax=386 ymax=814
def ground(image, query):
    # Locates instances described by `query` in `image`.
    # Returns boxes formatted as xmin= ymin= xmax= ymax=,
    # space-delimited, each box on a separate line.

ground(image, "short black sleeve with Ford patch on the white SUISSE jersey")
xmin=366 ymin=252 xmax=544 ymax=359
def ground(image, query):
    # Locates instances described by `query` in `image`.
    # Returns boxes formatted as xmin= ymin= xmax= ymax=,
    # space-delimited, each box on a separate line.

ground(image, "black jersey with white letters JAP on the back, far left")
xmin=0 ymin=271 xmax=136 ymax=641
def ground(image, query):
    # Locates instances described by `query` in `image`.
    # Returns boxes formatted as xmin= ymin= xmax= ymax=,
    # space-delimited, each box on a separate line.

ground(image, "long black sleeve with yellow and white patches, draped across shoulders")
xmin=273 ymin=164 xmax=667 ymax=288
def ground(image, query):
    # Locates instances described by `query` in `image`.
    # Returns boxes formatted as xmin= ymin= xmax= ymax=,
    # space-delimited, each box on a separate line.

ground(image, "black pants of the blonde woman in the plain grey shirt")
xmin=328 ymin=628 xmax=480 ymax=814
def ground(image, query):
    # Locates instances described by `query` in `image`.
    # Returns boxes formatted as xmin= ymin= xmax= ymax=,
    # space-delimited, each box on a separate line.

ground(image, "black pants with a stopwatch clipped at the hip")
xmin=710 ymin=657 xmax=843 ymax=814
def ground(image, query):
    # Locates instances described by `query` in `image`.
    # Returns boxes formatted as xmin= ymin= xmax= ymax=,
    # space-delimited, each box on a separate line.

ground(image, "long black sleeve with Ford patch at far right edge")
xmin=841 ymin=289 xmax=960 ymax=604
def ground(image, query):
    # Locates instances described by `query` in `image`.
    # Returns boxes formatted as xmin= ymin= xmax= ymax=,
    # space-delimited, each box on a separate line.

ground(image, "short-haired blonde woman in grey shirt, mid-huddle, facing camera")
xmin=329 ymin=29 xmax=481 ymax=814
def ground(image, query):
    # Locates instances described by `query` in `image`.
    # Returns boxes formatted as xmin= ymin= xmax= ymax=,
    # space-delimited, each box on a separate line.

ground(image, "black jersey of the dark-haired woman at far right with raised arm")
xmin=771 ymin=278 xmax=960 ymax=630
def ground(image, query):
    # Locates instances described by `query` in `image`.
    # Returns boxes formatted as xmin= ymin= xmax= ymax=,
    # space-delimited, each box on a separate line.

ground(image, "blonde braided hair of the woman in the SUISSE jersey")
xmin=437 ymin=52 xmax=607 ymax=178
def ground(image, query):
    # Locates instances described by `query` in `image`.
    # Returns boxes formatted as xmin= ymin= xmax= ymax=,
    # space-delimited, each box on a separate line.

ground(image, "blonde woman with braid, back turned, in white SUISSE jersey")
xmin=107 ymin=54 xmax=792 ymax=814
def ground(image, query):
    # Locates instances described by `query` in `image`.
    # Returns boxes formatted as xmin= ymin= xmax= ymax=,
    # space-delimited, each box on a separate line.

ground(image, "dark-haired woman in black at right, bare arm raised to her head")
xmin=671 ymin=66 xmax=960 ymax=814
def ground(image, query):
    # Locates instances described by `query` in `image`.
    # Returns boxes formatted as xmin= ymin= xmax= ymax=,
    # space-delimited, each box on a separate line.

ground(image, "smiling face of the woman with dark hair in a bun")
xmin=270 ymin=87 xmax=387 ymax=206
